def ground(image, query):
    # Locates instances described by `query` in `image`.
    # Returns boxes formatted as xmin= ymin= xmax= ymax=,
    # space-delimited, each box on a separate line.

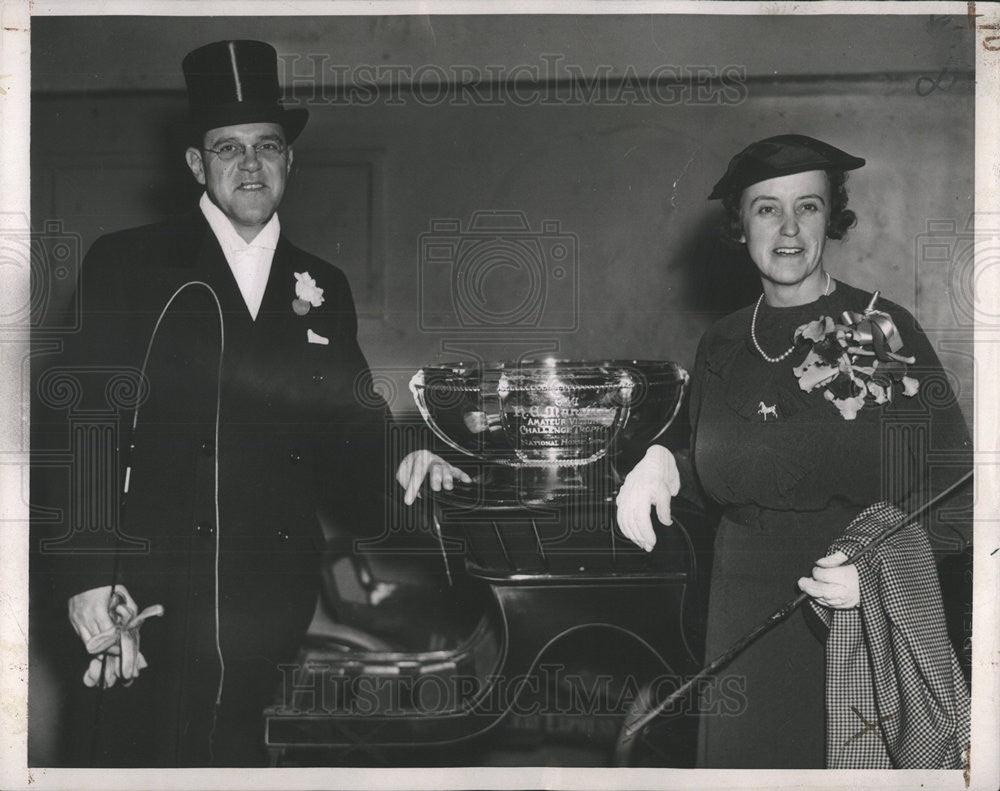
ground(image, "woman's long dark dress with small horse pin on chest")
xmin=691 ymin=283 xmax=971 ymax=769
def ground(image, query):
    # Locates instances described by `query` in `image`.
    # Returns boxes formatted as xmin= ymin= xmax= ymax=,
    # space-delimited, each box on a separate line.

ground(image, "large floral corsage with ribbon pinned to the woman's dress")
xmin=793 ymin=291 xmax=919 ymax=420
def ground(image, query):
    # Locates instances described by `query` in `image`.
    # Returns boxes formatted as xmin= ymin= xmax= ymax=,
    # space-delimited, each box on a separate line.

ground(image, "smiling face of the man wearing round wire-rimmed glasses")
xmin=186 ymin=123 xmax=292 ymax=242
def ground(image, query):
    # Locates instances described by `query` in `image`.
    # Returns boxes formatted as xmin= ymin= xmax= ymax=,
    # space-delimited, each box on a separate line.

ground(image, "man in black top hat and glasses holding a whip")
xmin=34 ymin=41 xmax=464 ymax=766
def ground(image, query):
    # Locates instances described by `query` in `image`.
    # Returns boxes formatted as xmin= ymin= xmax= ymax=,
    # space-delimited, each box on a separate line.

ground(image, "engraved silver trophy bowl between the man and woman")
xmin=410 ymin=359 xmax=688 ymax=496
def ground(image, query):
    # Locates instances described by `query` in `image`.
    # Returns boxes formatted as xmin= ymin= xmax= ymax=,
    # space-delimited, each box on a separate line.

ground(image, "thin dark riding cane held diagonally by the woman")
xmin=615 ymin=470 xmax=973 ymax=766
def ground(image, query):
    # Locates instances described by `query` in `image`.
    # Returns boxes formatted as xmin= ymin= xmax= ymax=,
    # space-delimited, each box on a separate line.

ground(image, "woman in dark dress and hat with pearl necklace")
xmin=618 ymin=135 xmax=971 ymax=769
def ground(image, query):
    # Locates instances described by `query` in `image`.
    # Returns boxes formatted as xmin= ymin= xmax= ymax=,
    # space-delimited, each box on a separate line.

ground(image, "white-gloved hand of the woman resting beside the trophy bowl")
xmin=615 ymin=445 xmax=681 ymax=552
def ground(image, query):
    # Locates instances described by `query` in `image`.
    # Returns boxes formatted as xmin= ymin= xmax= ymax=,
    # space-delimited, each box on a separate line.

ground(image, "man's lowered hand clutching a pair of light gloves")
xmin=69 ymin=585 xmax=163 ymax=687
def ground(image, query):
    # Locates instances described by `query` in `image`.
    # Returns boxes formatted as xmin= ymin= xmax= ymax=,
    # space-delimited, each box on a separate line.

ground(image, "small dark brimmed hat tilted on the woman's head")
xmin=708 ymin=135 xmax=865 ymax=200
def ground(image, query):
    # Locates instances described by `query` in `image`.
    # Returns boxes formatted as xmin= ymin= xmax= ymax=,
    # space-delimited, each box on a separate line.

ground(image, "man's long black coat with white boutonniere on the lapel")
xmin=32 ymin=211 xmax=389 ymax=766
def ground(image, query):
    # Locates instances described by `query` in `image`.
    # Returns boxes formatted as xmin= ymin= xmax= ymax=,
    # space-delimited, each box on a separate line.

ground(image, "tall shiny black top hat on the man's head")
xmin=181 ymin=41 xmax=309 ymax=143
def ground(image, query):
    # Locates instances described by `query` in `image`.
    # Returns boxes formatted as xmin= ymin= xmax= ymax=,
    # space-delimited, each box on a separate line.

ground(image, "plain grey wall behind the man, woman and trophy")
xmin=32 ymin=15 xmax=974 ymax=420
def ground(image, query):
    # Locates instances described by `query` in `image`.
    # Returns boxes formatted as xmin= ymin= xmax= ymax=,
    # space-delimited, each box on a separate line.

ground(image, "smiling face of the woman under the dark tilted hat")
xmin=740 ymin=170 xmax=830 ymax=287
